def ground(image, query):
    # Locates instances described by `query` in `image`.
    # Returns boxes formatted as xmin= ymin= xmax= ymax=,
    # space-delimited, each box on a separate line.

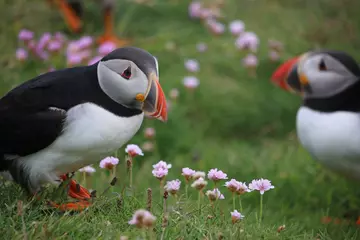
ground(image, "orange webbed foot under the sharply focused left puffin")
xmin=49 ymin=175 xmax=91 ymax=211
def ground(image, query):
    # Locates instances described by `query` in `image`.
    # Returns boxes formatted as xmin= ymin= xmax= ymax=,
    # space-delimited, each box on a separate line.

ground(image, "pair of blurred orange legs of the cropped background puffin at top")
xmin=47 ymin=0 xmax=129 ymax=47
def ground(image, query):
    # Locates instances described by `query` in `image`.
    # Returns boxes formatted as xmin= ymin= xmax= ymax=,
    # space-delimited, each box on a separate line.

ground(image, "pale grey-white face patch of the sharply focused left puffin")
xmin=97 ymin=59 xmax=150 ymax=109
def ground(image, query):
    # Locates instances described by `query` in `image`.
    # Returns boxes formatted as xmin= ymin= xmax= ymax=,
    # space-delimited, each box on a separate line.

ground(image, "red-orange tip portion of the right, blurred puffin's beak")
xmin=271 ymin=57 xmax=300 ymax=91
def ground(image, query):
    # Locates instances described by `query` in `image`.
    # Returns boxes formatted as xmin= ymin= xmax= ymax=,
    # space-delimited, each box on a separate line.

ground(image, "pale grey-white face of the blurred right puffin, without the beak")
xmin=298 ymin=53 xmax=359 ymax=98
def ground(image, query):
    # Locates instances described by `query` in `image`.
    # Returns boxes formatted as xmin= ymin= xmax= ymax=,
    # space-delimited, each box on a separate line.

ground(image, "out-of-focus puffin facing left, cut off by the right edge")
xmin=272 ymin=50 xmax=360 ymax=180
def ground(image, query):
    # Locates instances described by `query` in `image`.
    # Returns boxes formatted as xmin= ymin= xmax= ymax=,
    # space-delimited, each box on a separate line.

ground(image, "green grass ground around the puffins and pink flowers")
xmin=0 ymin=0 xmax=360 ymax=239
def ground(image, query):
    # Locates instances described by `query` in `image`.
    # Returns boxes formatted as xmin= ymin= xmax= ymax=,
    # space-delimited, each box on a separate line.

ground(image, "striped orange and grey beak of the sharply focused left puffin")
xmin=143 ymin=73 xmax=167 ymax=122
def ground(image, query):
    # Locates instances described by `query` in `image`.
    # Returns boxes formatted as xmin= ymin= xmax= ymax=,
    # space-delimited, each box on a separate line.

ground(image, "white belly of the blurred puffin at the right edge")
xmin=296 ymin=107 xmax=360 ymax=179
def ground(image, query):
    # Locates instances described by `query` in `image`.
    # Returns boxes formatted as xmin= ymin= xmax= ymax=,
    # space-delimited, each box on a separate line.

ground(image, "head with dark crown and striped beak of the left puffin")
xmin=97 ymin=47 xmax=167 ymax=122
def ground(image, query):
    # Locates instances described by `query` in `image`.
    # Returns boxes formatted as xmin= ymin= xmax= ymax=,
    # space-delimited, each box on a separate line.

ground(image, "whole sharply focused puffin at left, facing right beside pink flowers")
xmin=0 ymin=47 xmax=167 ymax=211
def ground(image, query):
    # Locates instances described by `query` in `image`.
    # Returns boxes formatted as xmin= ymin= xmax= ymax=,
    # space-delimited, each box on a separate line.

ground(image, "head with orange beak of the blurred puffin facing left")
xmin=271 ymin=50 xmax=360 ymax=99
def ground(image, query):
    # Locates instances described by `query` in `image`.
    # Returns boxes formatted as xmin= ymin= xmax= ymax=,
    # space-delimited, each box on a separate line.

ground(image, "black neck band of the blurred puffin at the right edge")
xmin=303 ymin=81 xmax=360 ymax=112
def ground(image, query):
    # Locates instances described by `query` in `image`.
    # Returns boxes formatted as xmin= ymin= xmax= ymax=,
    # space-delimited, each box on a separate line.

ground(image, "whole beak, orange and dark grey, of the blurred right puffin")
xmin=271 ymin=55 xmax=311 ymax=93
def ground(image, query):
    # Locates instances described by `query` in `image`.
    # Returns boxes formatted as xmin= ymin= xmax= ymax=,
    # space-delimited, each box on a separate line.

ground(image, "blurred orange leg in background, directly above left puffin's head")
xmin=98 ymin=8 xmax=130 ymax=47
